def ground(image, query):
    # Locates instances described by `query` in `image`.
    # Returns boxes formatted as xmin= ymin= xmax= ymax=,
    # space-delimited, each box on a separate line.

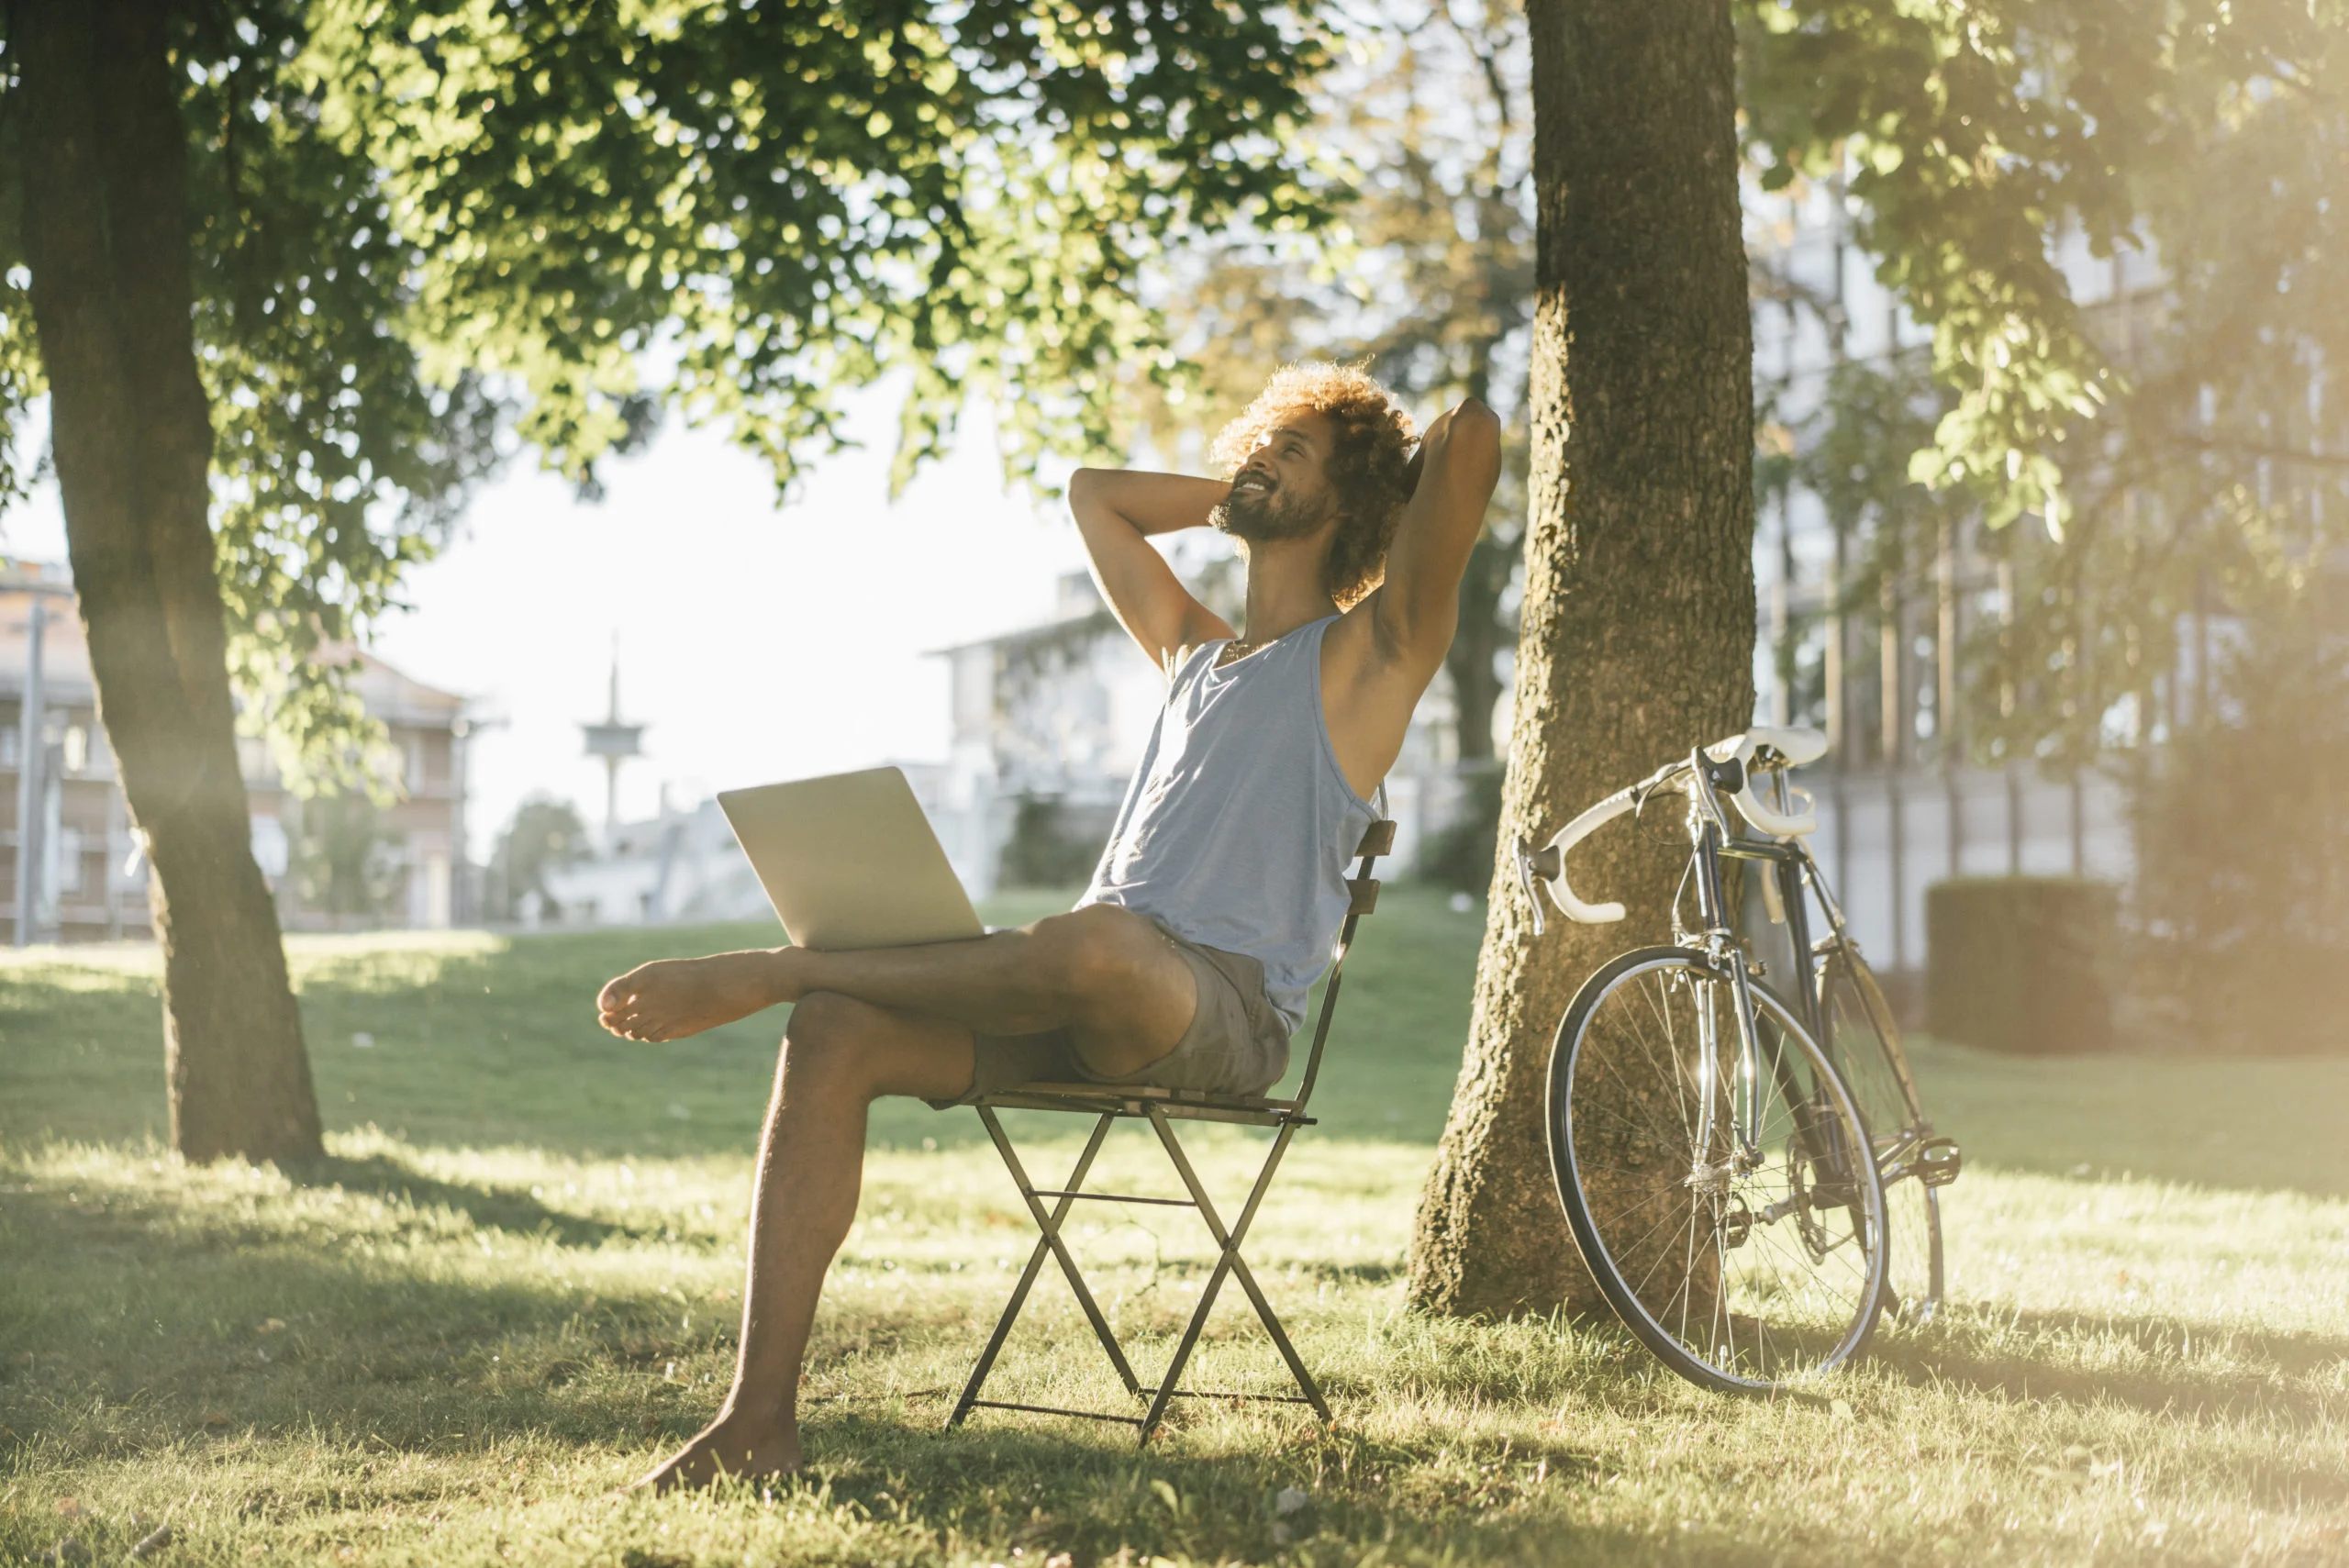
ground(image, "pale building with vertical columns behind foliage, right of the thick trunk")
xmin=1747 ymin=181 xmax=2159 ymax=972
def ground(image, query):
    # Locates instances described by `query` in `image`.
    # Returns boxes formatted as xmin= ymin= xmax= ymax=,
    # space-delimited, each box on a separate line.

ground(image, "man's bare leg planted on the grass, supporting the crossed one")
xmin=637 ymin=991 xmax=973 ymax=1491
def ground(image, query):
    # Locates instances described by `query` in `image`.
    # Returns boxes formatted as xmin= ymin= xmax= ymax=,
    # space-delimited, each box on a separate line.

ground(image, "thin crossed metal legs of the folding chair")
xmin=947 ymin=1103 xmax=1330 ymax=1443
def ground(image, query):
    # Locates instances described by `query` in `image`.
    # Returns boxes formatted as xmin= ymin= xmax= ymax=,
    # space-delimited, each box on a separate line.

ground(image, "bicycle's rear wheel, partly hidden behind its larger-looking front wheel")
xmin=1818 ymin=949 xmax=1943 ymax=1324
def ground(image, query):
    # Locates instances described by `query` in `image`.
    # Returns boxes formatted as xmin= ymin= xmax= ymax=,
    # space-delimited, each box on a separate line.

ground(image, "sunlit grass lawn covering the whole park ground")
xmin=0 ymin=890 xmax=2349 ymax=1568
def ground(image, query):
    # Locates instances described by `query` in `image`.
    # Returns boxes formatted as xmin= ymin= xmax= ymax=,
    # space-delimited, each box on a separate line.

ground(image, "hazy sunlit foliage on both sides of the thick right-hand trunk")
xmin=1153 ymin=0 xmax=2349 ymax=784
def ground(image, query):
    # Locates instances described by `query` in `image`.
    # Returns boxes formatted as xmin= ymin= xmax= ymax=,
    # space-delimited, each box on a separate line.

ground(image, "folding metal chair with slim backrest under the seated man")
xmin=947 ymin=819 xmax=1396 ymax=1443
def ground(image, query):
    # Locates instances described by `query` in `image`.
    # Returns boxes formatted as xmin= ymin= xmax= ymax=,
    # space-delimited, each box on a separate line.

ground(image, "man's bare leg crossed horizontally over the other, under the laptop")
xmin=596 ymin=904 xmax=1198 ymax=1075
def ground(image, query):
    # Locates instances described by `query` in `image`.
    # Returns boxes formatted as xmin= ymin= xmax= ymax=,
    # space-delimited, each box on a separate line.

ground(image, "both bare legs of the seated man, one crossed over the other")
xmin=599 ymin=906 xmax=1198 ymax=1491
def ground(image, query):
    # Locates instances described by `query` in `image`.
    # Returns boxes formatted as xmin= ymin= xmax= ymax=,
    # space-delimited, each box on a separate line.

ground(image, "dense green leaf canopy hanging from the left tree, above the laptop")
xmin=0 ymin=0 xmax=1325 ymax=770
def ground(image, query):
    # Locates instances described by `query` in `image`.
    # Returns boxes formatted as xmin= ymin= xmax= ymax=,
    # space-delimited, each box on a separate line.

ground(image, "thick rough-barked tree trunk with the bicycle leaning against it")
xmin=1412 ymin=0 xmax=1754 ymax=1315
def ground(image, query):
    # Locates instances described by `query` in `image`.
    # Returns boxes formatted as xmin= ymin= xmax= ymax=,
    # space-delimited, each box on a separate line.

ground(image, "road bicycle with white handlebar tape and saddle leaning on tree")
xmin=1515 ymin=728 xmax=1962 ymax=1392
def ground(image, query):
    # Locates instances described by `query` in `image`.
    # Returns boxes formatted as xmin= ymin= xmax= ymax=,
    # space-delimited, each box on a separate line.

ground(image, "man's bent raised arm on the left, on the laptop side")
xmin=1069 ymin=467 xmax=1230 ymax=669
